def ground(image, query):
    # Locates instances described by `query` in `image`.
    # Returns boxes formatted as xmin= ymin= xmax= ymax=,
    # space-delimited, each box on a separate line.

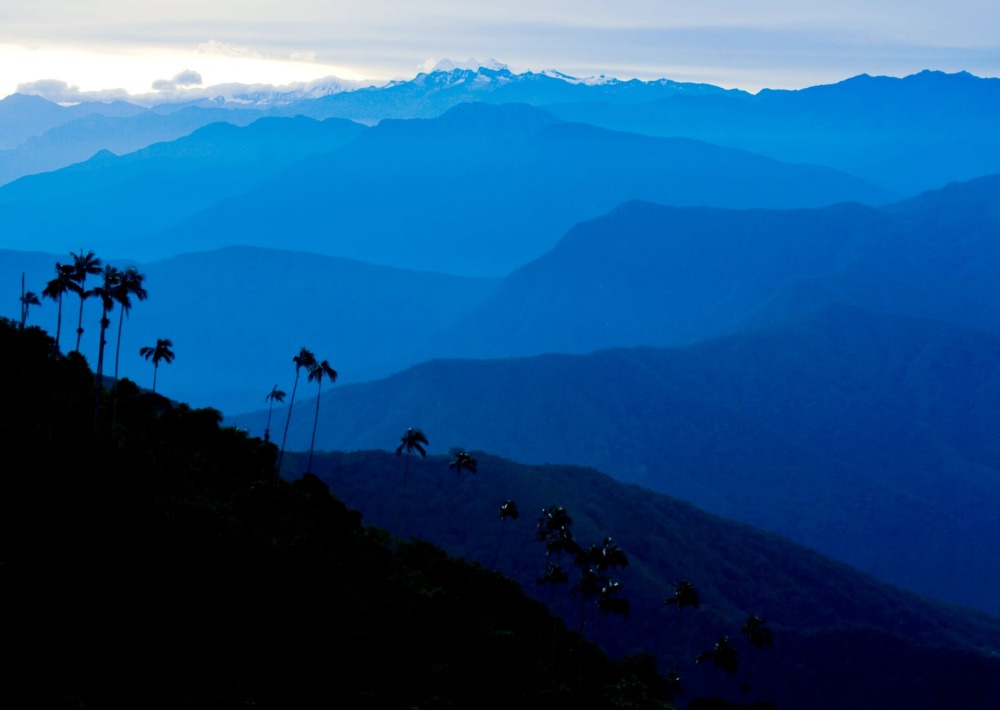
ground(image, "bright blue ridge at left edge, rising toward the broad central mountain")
xmin=0 ymin=114 xmax=364 ymax=253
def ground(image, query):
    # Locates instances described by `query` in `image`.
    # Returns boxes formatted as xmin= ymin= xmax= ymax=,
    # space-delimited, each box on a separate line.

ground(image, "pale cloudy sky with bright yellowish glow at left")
xmin=0 ymin=0 xmax=1000 ymax=101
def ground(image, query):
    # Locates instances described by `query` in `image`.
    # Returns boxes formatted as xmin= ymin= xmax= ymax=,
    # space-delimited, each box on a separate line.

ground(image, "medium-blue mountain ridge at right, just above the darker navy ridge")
xmin=421 ymin=176 xmax=1000 ymax=359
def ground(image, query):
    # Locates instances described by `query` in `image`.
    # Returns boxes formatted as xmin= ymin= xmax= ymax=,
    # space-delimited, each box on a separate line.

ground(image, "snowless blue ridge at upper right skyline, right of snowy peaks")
xmin=547 ymin=71 xmax=1000 ymax=194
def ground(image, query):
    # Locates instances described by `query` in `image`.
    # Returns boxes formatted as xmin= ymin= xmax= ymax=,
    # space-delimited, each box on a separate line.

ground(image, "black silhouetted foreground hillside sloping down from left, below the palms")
xmin=0 ymin=320 xmax=665 ymax=708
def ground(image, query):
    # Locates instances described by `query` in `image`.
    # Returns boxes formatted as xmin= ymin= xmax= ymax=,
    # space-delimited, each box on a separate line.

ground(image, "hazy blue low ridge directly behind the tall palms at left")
xmin=0 ymin=247 xmax=494 ymax=413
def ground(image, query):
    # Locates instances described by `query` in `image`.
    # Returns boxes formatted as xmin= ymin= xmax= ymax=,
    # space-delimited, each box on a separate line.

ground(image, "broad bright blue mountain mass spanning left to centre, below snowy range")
xmin=0 ymin=104 xmax=891 ymax=276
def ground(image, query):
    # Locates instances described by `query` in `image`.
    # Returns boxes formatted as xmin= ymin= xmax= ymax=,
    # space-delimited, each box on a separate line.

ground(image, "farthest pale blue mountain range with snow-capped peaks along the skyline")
xmin=0 ymin=63 xmax=1000 ymax=195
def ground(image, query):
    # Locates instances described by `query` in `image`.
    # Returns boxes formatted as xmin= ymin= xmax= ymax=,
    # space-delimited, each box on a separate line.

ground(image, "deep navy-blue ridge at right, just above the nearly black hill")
xmin=238 ymin=307 xmax=1000 ymax=613
